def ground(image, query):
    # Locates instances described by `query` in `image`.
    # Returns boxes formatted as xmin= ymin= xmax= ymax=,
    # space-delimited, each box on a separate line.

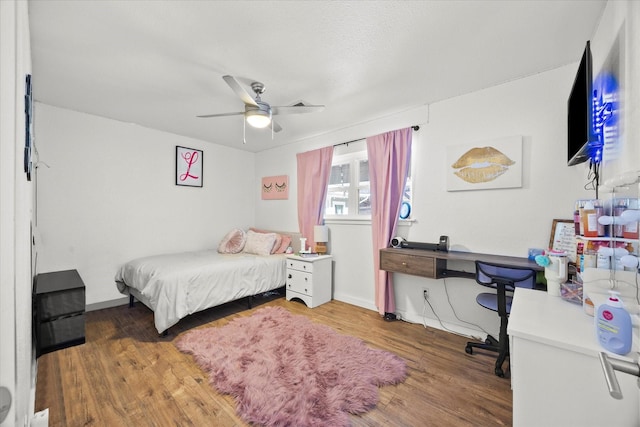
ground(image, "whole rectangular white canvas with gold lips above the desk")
xmin=446 ymin=135 xmax=523 ymax=191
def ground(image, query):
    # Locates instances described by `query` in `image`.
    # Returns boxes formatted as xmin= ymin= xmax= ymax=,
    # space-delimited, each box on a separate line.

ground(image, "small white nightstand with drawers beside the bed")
xmin=286 ymin=255 xmax=333 ymax=308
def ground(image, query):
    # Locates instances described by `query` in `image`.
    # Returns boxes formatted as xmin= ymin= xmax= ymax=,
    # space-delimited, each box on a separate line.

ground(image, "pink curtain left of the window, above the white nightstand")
xmin=297 ymin=146 xmax=333 ymax=249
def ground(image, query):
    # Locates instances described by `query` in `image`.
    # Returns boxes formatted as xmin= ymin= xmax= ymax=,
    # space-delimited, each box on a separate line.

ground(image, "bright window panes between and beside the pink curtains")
xmin=324 ymin=140 xmax=412 ymax=219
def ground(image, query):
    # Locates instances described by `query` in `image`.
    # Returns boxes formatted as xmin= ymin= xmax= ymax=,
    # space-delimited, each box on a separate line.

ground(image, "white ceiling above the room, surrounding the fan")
xmin=29 ymin=0 xmax=606 ymax=152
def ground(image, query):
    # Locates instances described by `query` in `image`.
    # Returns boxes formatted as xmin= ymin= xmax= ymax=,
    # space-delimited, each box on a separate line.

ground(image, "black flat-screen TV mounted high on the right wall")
xmin=567 ymin=41 xmax=599 ymax=166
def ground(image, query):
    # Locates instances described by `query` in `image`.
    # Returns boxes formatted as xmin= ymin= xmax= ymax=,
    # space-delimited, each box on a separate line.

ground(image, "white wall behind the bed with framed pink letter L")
xmin=35 ymin=104 xmax=257 ymax=305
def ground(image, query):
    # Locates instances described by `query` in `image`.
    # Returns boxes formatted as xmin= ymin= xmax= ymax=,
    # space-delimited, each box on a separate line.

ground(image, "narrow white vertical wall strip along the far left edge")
xmin=0 ymin=1 xmax=35 ymax=426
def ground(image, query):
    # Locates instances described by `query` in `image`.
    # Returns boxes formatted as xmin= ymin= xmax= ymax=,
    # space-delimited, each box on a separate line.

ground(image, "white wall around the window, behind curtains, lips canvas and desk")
xmin=256 ymin=64 xmax=593 ymax=333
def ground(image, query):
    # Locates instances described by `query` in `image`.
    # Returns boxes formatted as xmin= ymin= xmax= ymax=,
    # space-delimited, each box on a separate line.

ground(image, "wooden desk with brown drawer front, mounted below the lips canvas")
xmin=380 ymin=248 xmax=544 ymax=279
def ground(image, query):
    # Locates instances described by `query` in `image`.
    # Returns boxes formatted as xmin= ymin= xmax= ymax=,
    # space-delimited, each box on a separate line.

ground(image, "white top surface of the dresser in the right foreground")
xmin=507 ymin=288 xmax=640 ymax=360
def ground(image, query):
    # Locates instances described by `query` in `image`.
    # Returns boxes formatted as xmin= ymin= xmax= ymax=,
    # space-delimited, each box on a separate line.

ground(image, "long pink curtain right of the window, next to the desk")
xmin=367 ymin=128 xmax=412 ymax=315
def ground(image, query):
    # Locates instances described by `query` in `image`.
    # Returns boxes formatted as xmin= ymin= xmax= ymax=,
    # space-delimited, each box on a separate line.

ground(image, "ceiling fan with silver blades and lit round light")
xmin=198 ymin=75 xmax=324 ymax=138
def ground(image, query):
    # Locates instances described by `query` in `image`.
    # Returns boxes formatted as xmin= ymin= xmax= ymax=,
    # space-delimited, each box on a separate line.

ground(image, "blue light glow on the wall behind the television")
xmin=590 ymin=72 xmax=620 ymax=162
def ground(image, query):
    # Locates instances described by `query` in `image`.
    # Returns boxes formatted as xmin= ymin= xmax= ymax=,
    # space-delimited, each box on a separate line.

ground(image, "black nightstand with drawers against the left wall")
xmin=33 ymin=270 xmax=85 ymax=357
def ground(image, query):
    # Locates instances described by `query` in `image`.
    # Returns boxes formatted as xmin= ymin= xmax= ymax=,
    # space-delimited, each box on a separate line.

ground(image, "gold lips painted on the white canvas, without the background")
xmin=451 ymin=147 xmax=515 ymax=184
